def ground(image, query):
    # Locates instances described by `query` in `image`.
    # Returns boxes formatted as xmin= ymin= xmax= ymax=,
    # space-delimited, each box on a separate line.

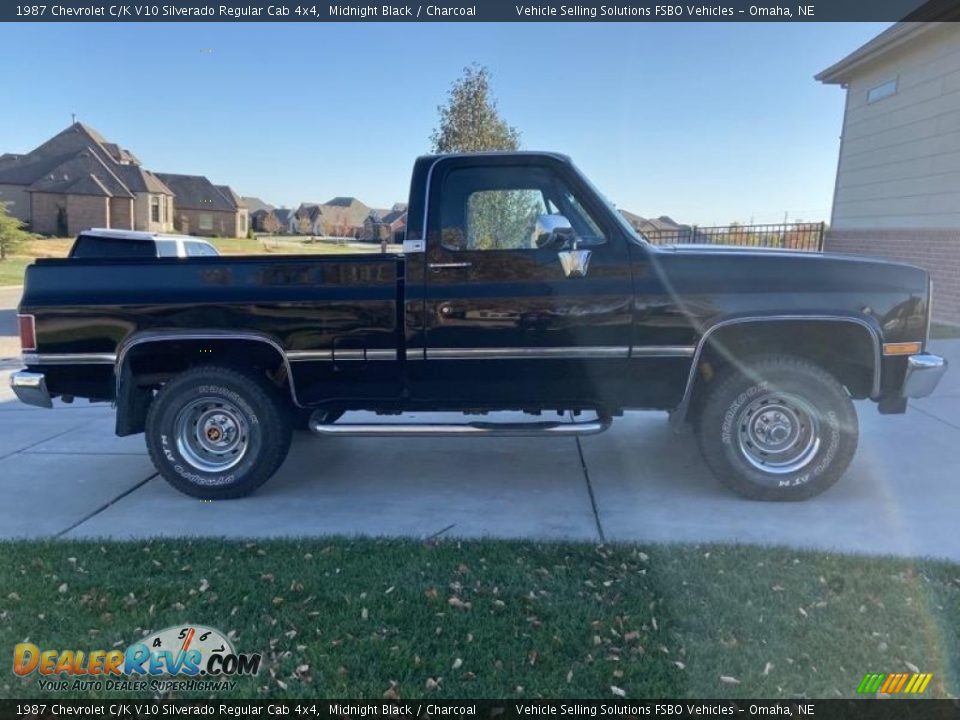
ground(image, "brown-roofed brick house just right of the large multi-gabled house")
xmin=157 ymin=173 xmax=248 ymax=237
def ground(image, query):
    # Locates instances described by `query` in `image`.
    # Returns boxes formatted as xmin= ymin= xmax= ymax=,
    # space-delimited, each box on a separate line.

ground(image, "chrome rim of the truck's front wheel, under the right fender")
xmin=737 ymin=393 xmax=820 ymax=475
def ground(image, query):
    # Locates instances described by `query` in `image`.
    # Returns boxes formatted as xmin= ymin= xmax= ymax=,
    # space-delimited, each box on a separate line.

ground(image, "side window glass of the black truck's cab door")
xmin=439 ymin=165 xmax=606 ymax=251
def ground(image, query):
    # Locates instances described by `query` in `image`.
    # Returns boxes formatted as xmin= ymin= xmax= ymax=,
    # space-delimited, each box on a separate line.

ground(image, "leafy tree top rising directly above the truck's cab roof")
xmin=430 ymin=64 xmax=520 ymax=153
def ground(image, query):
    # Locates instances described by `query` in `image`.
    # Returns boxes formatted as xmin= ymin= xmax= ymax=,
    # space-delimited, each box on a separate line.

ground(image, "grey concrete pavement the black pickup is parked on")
xmin=0 ymin=340 xmax=960 ymax=560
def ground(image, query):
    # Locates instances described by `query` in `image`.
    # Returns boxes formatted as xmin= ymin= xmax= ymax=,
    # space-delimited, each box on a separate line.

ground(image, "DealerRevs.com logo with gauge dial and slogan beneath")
xmin=13 ymin=625 xmax=261 ymax=692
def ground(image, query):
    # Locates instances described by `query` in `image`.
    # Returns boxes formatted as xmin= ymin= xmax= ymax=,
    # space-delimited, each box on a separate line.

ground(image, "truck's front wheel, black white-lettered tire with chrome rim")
xmin=697 ymin=355 xmax=858 ymax=500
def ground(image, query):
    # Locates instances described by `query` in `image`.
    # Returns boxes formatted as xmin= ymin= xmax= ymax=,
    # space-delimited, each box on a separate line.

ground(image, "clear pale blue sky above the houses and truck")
xmin=0 ymin=23 xmax=885 ymax=224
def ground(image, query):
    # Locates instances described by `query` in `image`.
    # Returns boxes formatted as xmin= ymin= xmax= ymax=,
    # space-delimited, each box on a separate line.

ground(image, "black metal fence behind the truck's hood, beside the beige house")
xmin=642 ymin=222 xmax=826 ymax=252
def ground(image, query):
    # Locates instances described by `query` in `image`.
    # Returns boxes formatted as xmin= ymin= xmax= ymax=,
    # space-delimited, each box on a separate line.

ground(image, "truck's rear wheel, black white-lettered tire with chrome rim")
xmin=146 ymin=366 xmax=291 ymax=500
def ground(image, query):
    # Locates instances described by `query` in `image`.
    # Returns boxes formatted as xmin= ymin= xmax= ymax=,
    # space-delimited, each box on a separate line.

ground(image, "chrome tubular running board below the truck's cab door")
xmin=310 ymin=417 xmax=611 ymax=437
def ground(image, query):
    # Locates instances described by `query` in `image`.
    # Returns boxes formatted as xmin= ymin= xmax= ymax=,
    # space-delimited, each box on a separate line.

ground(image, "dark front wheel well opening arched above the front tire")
xmin=690 ymin=320 xmax=876 ymax=416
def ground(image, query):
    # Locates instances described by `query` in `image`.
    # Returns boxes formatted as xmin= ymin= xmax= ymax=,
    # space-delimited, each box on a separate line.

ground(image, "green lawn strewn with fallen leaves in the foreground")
xmin=0 ymin=539 xmax=960 ymax=699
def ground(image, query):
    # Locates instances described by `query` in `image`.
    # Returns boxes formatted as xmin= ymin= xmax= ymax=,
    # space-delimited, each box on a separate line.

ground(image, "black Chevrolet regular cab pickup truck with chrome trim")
xmin=12 ymin=153 xmax=946 ymax=500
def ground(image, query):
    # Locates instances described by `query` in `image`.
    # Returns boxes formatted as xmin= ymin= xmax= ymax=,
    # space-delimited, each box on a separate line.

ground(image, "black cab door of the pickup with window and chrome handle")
xmin=407 ymin=156 xmax=633 ymax=407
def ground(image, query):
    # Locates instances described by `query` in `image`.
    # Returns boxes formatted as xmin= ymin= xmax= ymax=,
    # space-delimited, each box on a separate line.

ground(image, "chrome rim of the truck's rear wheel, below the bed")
xmin=174 ymin=397 xmax=249 ymax=473
